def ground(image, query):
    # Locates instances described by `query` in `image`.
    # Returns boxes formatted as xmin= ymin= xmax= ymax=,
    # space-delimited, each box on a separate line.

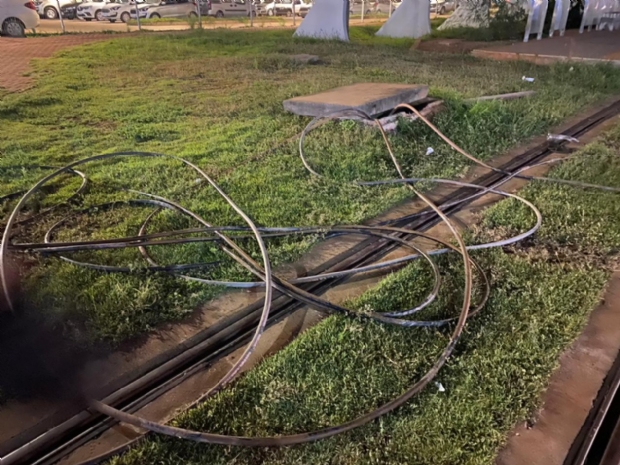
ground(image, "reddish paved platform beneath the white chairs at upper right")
xmin=471 ymin=30 xmax=620 ymax=66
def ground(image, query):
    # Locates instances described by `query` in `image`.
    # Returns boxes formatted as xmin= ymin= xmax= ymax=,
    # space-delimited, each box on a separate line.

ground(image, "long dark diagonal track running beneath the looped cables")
xmin=0 ymin=101 xmax=620 ymax=465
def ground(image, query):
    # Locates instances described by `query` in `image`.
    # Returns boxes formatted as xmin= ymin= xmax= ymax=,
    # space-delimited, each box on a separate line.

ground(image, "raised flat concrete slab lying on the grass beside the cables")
xmin=284 ymin=82 xmax=428 ymax=116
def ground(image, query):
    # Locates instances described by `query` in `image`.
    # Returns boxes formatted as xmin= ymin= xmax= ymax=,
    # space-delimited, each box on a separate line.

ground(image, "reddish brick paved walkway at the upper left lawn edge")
xmin=0 ymin=34 xmax=110 ymax=92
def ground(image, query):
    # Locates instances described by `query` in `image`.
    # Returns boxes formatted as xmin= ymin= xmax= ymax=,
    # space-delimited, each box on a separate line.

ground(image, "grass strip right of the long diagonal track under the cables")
xmin=110 ymin=120 xmax=620 ymax=465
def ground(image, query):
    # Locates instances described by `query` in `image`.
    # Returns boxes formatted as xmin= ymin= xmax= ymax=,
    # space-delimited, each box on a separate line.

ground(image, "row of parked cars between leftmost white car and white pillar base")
xmin=35 ymin=0 xmax=312 ymax=23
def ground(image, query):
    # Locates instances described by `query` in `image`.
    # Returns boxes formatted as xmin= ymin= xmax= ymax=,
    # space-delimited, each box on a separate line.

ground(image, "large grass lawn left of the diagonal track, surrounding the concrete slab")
xmin=0 ymin=27 xmax=620 ymax=341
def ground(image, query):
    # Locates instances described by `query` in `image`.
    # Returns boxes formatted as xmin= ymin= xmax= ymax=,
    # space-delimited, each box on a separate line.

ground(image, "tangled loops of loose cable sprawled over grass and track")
xmin=0 ymin=104 xmax=620 ymax=447
